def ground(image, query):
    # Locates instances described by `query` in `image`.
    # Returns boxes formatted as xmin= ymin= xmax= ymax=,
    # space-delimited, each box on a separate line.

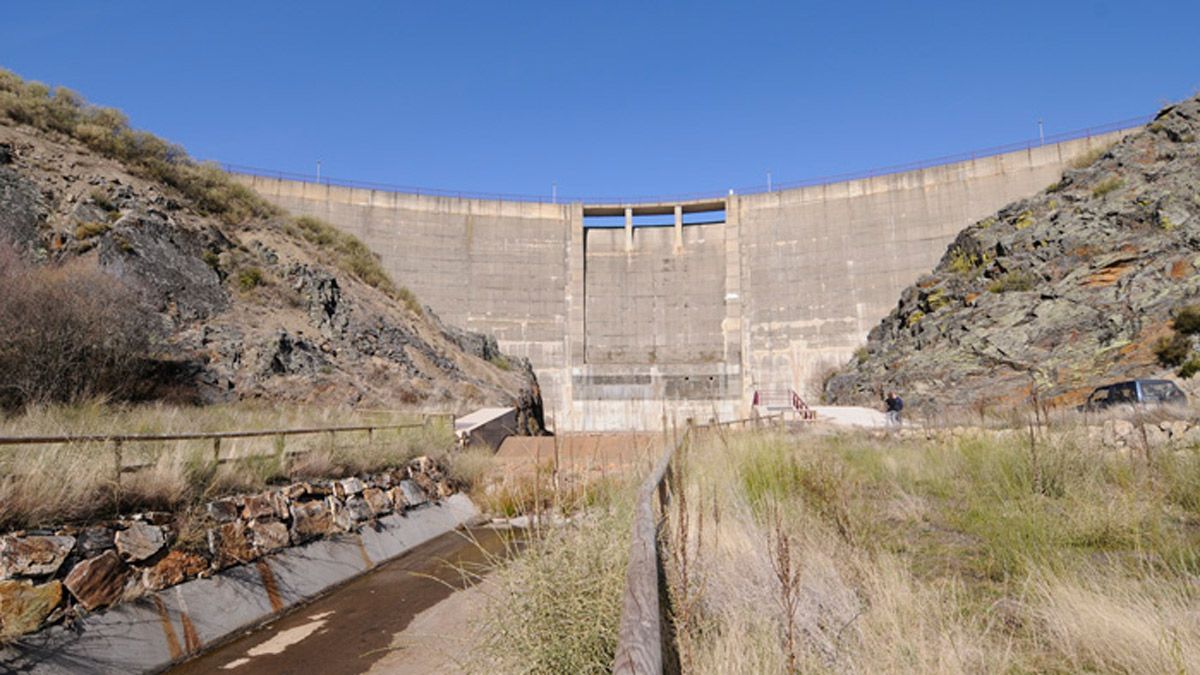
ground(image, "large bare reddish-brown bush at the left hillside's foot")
xmin=0 ymin=244 xmax=152 ymax=410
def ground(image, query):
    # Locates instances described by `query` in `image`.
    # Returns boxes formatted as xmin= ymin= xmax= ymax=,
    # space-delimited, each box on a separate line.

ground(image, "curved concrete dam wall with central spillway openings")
xmin=238 ymin=130 xmax=1128 ymax=431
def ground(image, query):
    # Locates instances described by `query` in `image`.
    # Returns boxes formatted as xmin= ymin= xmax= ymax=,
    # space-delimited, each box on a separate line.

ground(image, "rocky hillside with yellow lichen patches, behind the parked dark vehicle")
xmin=824 ymin=97 xmax=1200 ymax=410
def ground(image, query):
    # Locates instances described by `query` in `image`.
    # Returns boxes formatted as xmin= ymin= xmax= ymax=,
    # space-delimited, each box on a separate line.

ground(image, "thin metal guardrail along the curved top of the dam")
xmin=218 ymin=115 xmax=1154 ymax=204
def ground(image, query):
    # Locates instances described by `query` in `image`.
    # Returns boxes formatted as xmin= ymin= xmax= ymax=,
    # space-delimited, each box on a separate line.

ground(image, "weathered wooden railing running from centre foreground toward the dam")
xmin=612 ymin=414 xmax=782 ymax=675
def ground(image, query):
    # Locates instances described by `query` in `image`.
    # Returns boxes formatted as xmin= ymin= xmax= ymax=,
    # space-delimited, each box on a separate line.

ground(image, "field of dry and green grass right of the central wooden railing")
xmin=667 ymin=426 xmax=1200 ymax=673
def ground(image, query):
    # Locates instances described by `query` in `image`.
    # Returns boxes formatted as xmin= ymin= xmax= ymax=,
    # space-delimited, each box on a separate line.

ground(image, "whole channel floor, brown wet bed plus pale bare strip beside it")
xmin=169 ymin=528 xmax=506 ymax=675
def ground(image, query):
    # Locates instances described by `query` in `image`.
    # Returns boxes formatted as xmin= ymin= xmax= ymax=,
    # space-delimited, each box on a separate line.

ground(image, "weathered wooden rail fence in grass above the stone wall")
xmin=0 ymin=413 xmax=452 ymax=483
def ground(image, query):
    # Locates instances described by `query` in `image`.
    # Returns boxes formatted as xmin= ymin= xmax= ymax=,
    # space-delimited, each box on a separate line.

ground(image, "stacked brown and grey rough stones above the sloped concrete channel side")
xmin=0 ymin=456 xmax=456 ymax=639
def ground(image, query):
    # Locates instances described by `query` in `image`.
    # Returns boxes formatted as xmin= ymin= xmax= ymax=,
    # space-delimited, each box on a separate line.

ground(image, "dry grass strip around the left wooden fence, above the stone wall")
xmin=0 ymin=402 xmax=454 ymax=530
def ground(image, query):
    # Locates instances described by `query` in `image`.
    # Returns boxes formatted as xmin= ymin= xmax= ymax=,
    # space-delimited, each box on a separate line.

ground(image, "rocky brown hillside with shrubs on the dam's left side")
xmin=0 ymin=71 xmax=541 ymax=426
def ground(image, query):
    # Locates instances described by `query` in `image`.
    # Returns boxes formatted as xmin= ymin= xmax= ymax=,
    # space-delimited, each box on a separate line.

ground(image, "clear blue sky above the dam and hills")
xmin=0 ymin=0 xmax=1200 ymax=196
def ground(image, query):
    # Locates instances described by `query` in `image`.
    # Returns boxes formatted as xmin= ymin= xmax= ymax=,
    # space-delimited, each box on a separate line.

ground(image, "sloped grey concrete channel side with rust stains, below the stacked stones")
xmin=0 ymin=494 xmax=479 ymax=674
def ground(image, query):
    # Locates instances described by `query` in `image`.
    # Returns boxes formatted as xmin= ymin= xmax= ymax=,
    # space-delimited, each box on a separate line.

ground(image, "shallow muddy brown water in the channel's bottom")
xmin=168 ymin=528 xmax=515 ymax=675
